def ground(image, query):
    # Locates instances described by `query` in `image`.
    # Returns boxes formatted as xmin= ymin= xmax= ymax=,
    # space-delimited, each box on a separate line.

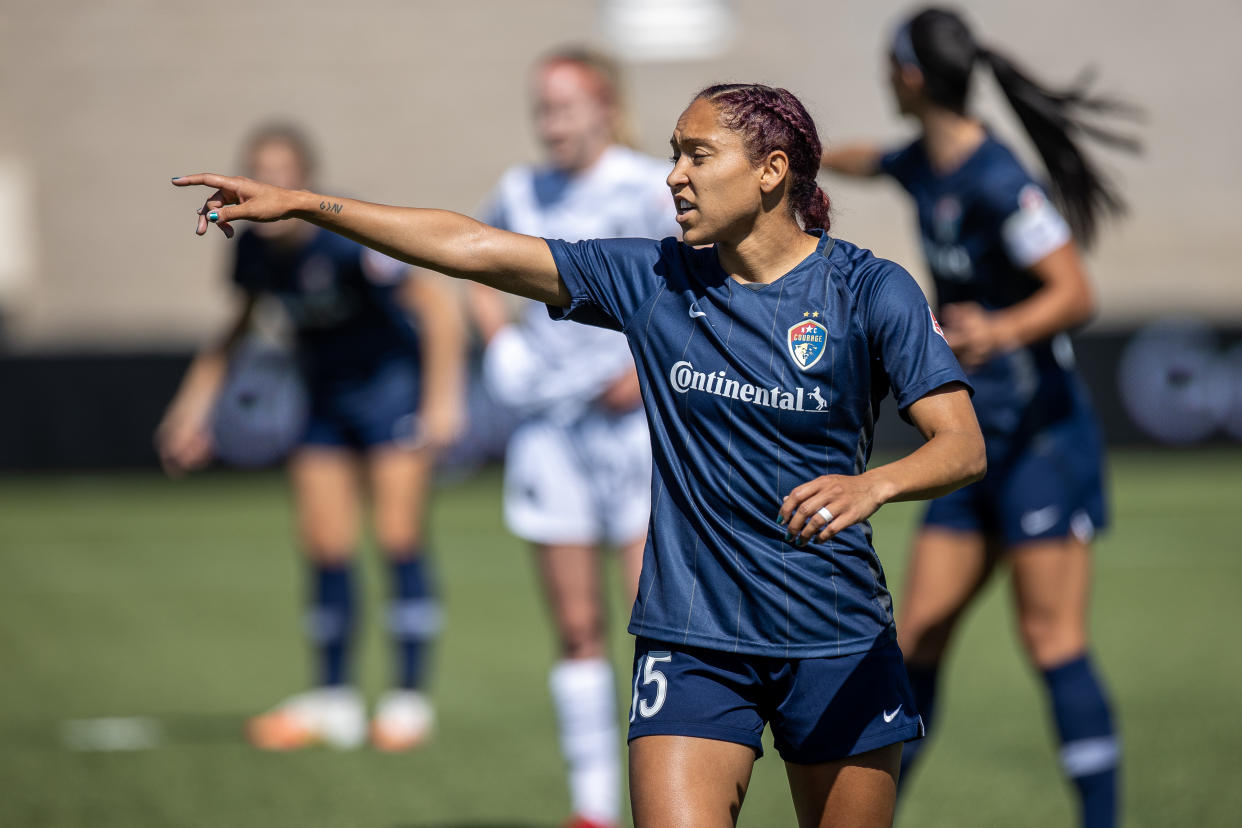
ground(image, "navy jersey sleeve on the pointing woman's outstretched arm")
xmin=546 ymin=238 xmax=661 ymax=330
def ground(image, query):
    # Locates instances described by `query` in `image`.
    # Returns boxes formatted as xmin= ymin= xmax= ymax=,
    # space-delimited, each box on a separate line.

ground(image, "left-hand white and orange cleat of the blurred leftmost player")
xmin=246 ymin=686 xmax=366 ymax=751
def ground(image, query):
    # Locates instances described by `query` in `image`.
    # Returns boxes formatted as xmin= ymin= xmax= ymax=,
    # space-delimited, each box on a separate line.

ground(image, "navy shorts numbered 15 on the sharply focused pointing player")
xmin=630 ymin=636 xmax=923 ymax=765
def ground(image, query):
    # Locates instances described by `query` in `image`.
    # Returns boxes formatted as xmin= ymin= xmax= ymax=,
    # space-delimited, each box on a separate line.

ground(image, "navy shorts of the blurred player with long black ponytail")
xmin=923 ymin=416 xmax=1108 ymax=547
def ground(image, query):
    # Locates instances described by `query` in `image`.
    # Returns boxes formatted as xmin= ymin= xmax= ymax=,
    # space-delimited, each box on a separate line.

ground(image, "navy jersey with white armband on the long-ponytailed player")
xmin=881 ymin=135 xmax=1089 ymax=439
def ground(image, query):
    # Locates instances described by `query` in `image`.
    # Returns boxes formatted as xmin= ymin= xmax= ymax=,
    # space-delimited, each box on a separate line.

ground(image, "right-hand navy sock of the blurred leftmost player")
xmin=389 ymin=549 xmax=440 ymax=690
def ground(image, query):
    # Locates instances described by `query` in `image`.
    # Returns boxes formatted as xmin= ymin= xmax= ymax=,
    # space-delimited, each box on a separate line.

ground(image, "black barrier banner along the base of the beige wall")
xmin=0 ymin=318 xmax=1242 ymax=470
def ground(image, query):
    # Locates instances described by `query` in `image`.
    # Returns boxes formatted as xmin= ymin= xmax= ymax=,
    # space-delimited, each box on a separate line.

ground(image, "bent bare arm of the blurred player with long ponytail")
xmin=940 ymin=242 xmax=1095 ymax=369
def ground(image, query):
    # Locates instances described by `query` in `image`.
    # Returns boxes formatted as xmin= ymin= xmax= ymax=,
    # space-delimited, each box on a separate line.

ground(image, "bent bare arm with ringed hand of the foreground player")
xmin=776 ymin=382 xmax=987 ymax=546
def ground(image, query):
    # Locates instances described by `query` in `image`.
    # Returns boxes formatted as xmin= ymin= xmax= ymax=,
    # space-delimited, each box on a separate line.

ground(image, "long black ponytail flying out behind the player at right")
xmin=979 ymin=48 xmax=1141 ymax=247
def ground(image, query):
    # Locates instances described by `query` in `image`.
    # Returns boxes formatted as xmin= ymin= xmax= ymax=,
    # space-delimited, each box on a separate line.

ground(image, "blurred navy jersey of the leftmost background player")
xmin=233 ymin=228 xmax=419 ymax=386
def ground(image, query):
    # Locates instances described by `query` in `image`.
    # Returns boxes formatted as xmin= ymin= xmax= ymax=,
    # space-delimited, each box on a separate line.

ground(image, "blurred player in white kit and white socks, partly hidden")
xmin=469 ymin=48 xmax=681 ymax=827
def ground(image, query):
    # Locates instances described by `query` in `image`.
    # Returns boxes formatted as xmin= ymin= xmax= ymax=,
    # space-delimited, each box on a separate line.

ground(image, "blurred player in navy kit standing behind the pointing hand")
xmin=156 ymin=127 xmax=465 ymax=751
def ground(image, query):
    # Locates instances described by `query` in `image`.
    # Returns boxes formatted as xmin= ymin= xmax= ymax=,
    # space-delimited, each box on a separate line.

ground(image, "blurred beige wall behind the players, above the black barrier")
xmin=0 ymin=0 xmax=1242 ymax=351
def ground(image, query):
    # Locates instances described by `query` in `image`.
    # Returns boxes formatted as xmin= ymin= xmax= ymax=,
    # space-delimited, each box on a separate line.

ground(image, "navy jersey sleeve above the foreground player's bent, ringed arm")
xmin=863 ymin=262 xmax=974 ymax=420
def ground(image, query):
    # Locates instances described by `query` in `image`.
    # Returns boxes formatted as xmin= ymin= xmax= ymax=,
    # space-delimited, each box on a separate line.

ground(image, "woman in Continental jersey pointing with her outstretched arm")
xmin=174 ymin=84 xmax=984 ymax=827
